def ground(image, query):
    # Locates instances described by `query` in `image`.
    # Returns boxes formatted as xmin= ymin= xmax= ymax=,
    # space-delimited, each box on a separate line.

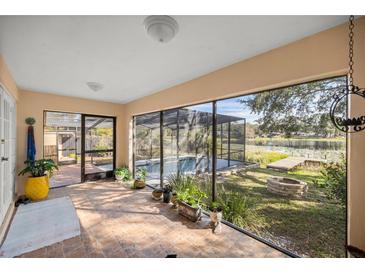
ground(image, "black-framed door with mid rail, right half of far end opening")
xmin=81 ymin=114 xmax=116 ymax=181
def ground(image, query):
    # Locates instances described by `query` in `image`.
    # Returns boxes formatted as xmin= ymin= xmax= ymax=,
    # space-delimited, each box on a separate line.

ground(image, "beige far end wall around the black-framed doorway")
xmin=17 ymin=90 xmax=127 ymax=194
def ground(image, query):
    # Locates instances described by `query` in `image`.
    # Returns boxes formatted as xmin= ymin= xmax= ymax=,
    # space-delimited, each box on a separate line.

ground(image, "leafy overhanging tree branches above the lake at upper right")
xmin=240 ymin=77 xmax=346 ymax=137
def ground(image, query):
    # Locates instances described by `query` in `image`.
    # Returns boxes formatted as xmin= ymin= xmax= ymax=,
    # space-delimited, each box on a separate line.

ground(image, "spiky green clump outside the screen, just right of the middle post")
xmin=217 ymin=191 xmax=253 ymax=227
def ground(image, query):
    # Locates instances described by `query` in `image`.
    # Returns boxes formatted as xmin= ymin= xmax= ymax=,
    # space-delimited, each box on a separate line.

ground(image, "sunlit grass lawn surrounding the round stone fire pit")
xmin=217 ymin=168 xmax=346 ymax=257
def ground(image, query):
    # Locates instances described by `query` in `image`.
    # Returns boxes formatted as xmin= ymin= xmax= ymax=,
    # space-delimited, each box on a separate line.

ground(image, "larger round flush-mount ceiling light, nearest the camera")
xmin=143 ymin=15 xmax=179 ymax=43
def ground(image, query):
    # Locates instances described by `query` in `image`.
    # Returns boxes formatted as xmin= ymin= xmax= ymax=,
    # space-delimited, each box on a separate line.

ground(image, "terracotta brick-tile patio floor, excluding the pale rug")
xmin=21 ymin=181 xmax=286 ymax=258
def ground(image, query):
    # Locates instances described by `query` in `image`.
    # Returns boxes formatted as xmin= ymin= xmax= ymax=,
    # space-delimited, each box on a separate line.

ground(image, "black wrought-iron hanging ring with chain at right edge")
xmin=330 ymin=15 xmax=365 ymax=133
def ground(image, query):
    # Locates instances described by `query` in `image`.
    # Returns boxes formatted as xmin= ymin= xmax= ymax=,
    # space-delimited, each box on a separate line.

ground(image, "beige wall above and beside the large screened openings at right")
xmin=123 ymin=17 xmax=365 ymax=253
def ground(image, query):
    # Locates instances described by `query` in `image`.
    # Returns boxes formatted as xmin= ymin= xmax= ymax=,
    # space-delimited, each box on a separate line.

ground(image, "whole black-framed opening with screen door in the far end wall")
xmin=43 ymin=111 xmax=116 ymax=187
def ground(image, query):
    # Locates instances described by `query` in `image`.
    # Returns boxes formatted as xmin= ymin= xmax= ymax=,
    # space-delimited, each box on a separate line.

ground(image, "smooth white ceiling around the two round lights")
xmin=0 ymin=16 xmax=347 ymax=103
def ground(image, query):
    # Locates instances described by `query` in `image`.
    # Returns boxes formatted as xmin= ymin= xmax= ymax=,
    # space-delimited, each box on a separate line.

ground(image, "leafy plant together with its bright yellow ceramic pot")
xmin=18 ymin=159 xmax=58 ymax=201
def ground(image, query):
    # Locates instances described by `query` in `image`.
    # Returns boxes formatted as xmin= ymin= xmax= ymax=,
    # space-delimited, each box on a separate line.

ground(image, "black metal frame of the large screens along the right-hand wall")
xmin=132 ymin=74 xmax=348 ymax=258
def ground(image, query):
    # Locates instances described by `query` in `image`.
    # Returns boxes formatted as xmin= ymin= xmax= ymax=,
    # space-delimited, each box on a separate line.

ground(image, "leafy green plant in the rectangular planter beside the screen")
xmin=177 ymin=184 xmax=207 ymax=222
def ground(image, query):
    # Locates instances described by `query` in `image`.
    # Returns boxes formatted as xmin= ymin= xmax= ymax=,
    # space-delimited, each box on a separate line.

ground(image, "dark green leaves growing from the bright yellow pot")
xmin=18 ymin=159 xmax=58 ymax=177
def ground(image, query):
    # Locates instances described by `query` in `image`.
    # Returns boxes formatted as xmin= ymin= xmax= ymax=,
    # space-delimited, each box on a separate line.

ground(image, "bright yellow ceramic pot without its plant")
xmin=25 ymin=176 xmax=49 ymax=201
